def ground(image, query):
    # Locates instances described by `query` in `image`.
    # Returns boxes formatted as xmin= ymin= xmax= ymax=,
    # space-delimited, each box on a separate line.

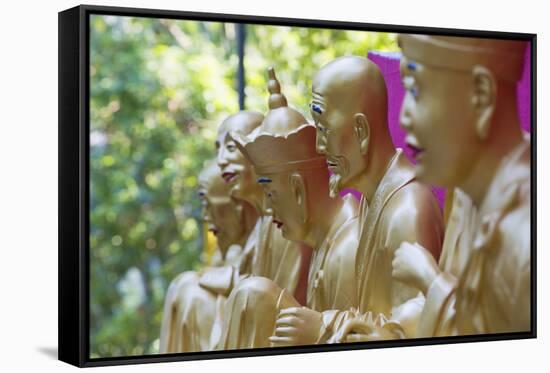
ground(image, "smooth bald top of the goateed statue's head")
xmin=312 ymin=56 xmax=388 ymax=130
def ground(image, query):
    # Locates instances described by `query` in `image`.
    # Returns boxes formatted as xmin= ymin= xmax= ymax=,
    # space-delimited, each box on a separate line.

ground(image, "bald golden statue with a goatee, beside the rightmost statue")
xmin=310 ymin=56 xmax=443 ymax=342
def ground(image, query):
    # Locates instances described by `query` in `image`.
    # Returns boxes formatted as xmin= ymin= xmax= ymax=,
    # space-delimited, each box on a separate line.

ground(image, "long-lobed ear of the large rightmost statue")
xmin=472 ymin=66 xmax=497 ymax=140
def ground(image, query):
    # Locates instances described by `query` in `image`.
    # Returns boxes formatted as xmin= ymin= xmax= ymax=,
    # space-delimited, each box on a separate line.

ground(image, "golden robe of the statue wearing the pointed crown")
xmin=218 ymin=195 xmax=358 ymax=350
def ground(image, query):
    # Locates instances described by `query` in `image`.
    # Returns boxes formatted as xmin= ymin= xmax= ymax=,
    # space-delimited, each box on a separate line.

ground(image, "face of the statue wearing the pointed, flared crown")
xmin=258 ymin=172 xmax=307 ymax=242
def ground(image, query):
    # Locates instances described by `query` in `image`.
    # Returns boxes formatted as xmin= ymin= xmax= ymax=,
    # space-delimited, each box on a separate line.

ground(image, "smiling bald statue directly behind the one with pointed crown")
xmin=216 ymin=111 xmax=310 ymax=302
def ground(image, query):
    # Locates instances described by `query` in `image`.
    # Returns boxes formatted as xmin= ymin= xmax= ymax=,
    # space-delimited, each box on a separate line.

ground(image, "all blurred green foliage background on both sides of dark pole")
xmin=90 ymin=16 xmax=396 ymax=357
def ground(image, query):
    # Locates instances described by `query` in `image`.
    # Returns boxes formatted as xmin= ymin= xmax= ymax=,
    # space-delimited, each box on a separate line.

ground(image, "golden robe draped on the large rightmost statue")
xmin=418 ymin=140 xmax=531 ymax=337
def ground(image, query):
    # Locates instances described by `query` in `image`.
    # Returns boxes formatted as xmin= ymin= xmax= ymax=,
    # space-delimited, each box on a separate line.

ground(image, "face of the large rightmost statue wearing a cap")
xmin=400 ymin=57 xmax=481 ymax=187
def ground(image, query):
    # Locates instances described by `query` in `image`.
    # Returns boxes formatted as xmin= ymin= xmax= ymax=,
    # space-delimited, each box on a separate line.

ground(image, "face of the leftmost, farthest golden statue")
xmin=199 ymin=184 xmax=244 ymax=252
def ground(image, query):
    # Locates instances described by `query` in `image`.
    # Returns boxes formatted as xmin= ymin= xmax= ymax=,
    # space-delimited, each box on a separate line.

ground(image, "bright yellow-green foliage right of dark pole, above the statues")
xmin=245 ymin=25 xmax=397 ymax=115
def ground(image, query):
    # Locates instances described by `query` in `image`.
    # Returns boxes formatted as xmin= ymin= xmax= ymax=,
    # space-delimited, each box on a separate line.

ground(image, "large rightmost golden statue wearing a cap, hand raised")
xmin=394 ymin=35 xmax=531 ymax=337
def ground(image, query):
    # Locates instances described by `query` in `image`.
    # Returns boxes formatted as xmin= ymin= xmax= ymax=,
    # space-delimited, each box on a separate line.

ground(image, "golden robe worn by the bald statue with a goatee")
xmin=323 ymin=149 xmax=444 ymax=342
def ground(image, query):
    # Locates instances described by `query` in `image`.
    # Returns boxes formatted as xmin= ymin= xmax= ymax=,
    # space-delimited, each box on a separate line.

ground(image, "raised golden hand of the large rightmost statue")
xmin=392 ymin=242 xmax=439 ymax=295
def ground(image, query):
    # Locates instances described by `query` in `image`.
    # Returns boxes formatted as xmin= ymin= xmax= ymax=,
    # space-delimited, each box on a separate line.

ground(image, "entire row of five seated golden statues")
xmin=160 ymin=34 xmax=531 ymax=353
